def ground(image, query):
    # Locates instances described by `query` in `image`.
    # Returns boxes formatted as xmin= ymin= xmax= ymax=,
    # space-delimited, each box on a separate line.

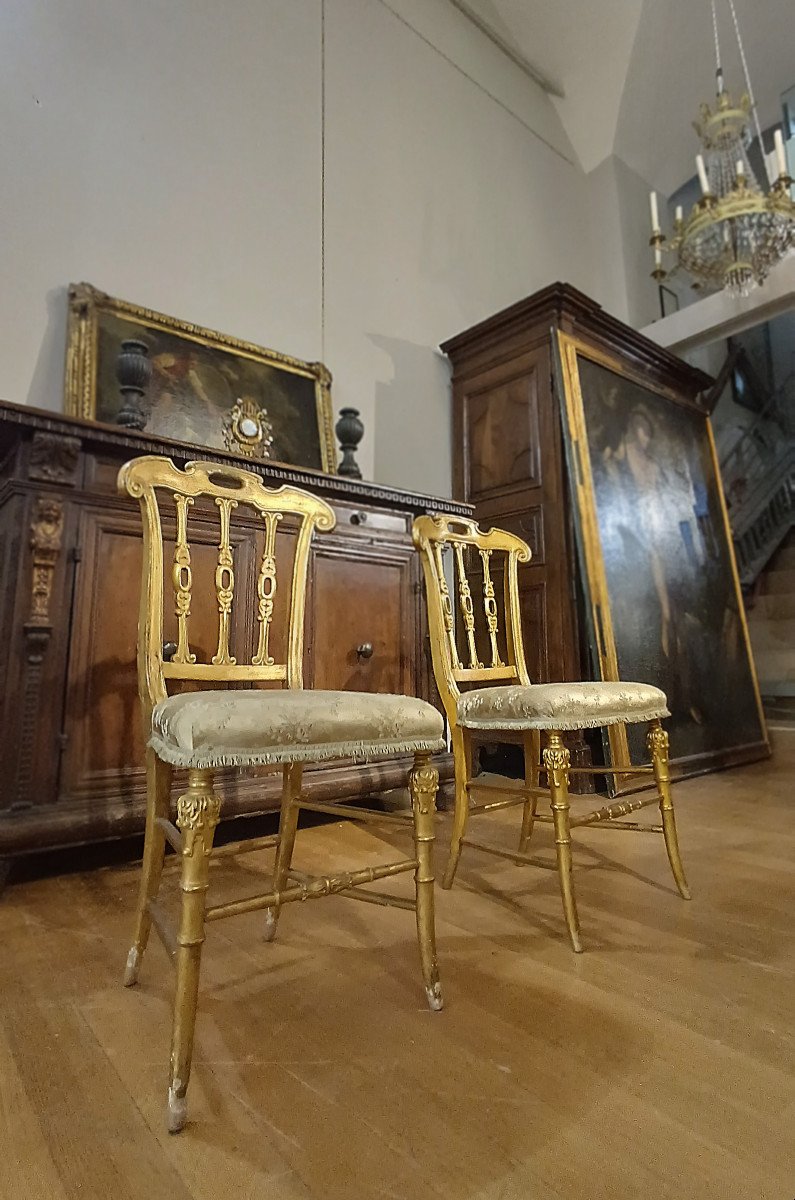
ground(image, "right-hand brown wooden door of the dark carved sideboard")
xmin=306 ymin=538 xmax=423 ymax=696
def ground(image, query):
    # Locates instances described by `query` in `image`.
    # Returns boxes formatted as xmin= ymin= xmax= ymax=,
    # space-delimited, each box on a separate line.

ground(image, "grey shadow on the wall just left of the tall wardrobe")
xmin=367 ymin=334 xmax=452 ymax=496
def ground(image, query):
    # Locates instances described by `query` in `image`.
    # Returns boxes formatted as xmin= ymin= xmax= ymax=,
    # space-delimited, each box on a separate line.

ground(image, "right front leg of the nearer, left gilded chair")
xmin=408 ymin=754 xmax=442 ymax=1012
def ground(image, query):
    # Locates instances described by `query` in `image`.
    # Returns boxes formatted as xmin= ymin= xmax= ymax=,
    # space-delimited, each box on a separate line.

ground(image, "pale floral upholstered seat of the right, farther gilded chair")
xmin=458 ymin=683 xmax=670 ymax=730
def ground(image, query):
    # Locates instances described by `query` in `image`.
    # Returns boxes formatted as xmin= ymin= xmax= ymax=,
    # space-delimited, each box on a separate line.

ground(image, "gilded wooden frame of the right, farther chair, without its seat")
xmin=413 ymin=515 xmax=691 ymax=952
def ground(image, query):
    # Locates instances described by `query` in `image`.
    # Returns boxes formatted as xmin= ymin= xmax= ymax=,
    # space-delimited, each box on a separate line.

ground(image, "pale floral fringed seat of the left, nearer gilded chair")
xmin=149 ymin=689 xmax=446 ymax=768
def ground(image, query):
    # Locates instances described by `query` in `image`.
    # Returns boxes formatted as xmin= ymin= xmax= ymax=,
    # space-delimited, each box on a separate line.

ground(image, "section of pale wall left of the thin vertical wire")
xmin=0 ymin=0 xmax=321 ymax=409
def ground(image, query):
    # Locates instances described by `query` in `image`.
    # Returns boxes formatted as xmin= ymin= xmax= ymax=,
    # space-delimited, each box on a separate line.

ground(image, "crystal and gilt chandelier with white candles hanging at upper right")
xmin=648 ymin=0 xmax=795 ymax=296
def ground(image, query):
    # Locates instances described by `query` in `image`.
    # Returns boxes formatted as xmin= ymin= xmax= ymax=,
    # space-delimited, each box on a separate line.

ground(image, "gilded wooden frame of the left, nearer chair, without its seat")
xmin=118 ymin=456 xmax=442 ymax=1133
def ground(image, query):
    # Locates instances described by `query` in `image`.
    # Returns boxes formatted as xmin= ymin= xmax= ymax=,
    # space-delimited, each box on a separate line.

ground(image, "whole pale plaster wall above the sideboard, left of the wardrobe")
xmin=0 ymin=0 xmax=599 ymax=493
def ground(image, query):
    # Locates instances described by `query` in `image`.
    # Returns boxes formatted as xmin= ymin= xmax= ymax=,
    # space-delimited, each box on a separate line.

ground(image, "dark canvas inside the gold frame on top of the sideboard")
xmin=96 ymin=308 xmax=324 ymax=470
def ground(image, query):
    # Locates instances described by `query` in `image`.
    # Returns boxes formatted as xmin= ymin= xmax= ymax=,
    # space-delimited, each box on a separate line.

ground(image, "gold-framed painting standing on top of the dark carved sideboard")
xmin=65 ymin=283 xmax=336 ymax=473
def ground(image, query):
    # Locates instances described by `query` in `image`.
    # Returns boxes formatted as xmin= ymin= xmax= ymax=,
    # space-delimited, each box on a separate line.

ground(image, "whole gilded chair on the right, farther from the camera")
xmin=413 ymin=515 xmax=689 ymax=952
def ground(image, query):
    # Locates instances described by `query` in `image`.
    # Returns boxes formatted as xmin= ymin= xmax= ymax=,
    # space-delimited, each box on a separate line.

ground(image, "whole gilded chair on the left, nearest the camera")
xmin=118 ymin=456 xmax=444 ymax=1133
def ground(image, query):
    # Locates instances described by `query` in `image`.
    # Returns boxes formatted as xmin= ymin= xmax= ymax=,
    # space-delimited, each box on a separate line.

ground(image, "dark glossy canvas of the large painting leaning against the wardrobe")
xmin=578 ymin=355 xmax=766 ymax=762
